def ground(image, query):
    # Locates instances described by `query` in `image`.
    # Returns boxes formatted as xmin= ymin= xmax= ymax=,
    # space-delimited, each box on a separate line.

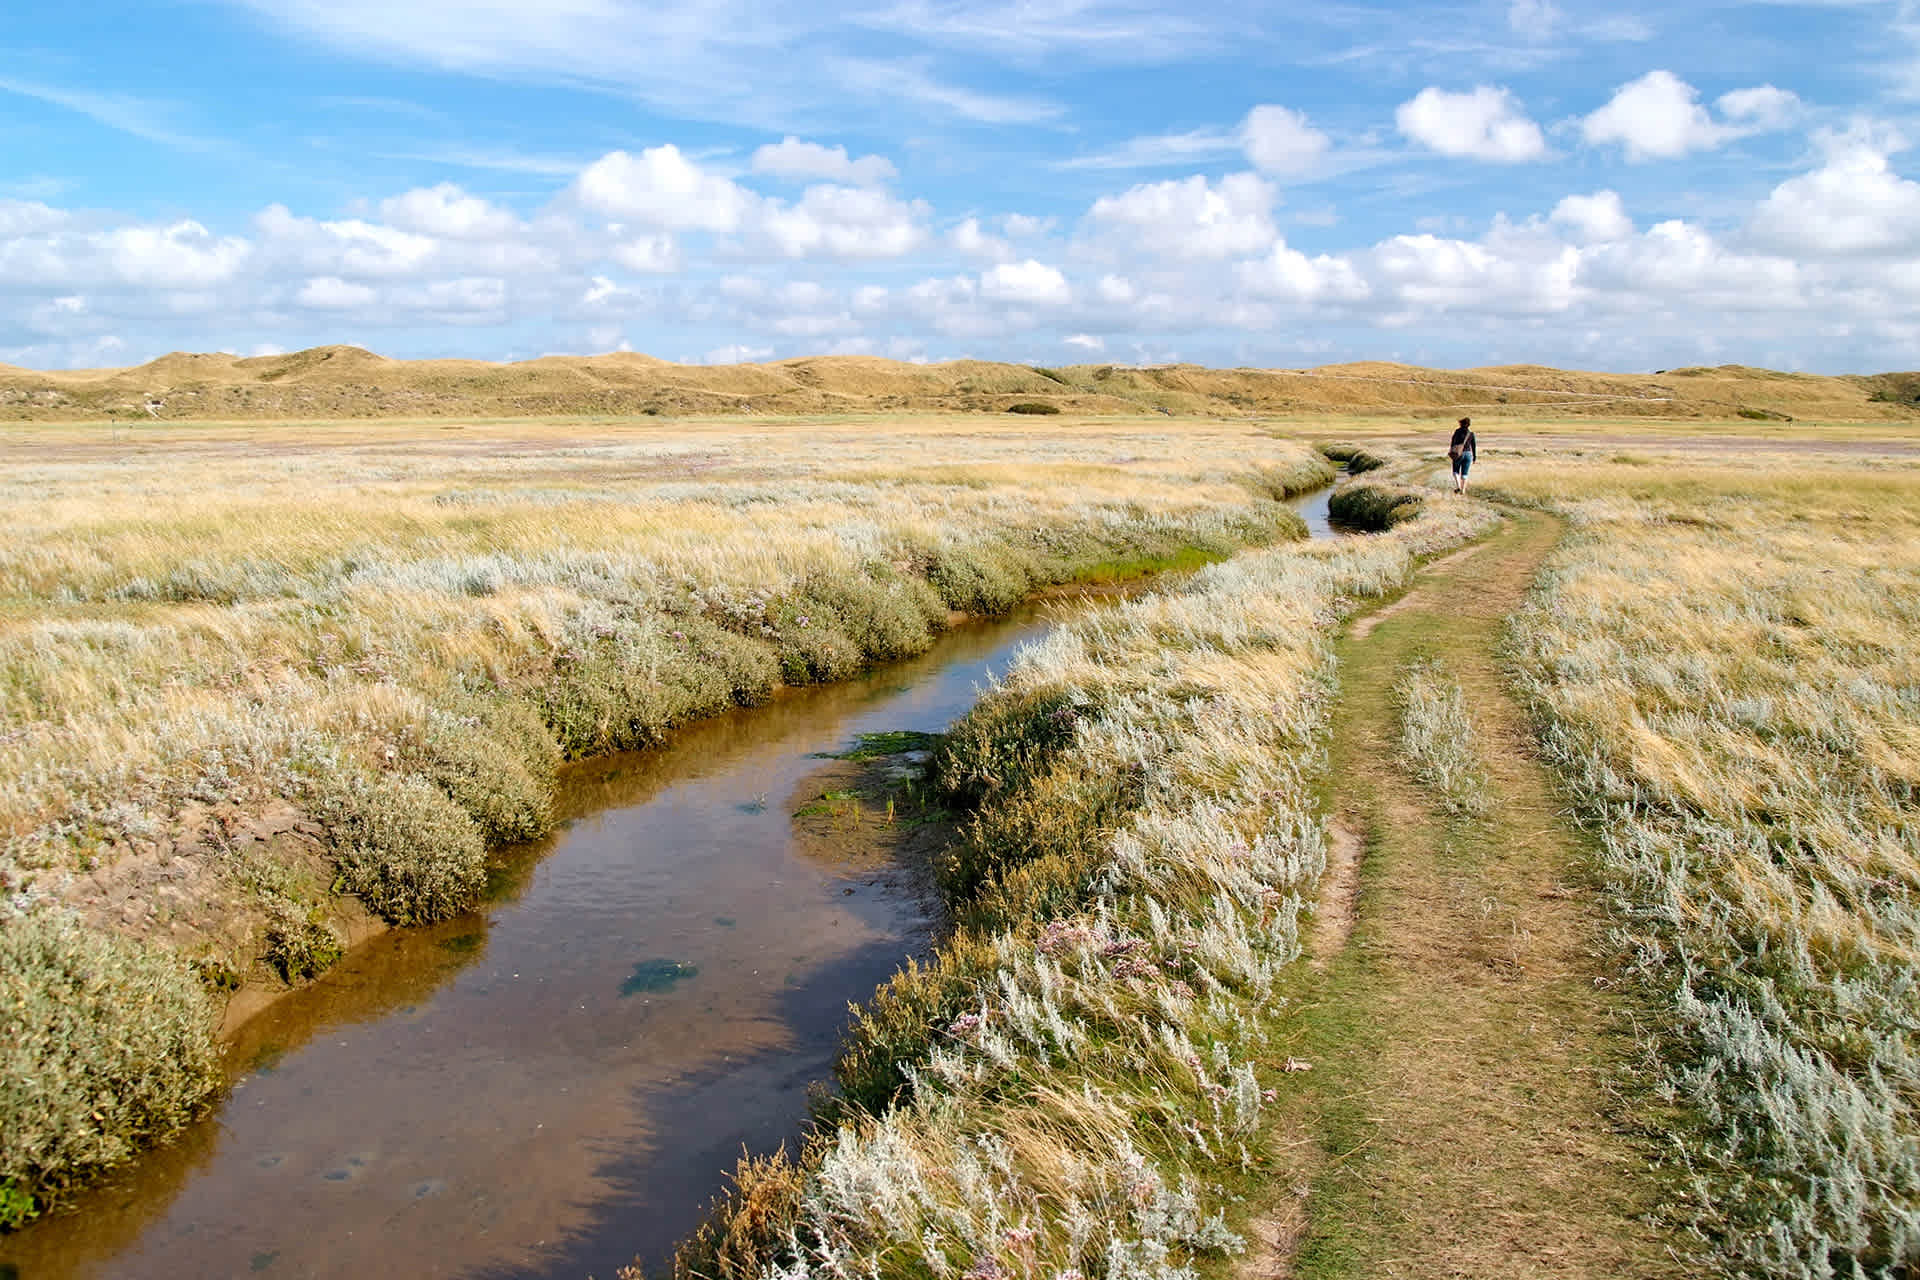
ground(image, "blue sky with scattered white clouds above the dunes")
xmin=0 ymin=0 xmax=1920 ymax=372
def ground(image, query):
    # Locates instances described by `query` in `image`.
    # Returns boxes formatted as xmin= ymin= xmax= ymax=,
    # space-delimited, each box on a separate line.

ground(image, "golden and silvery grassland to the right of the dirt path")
xmin=1501 ymin=457 xmax=1920 ymax=1278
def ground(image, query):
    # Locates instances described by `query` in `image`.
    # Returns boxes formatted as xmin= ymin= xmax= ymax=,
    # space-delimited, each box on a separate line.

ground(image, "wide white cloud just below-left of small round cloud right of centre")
xmin=1087 ymin=173 xmax=1279 ymax=259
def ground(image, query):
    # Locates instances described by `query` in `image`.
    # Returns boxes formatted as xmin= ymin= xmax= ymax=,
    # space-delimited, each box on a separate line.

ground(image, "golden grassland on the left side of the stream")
xmin=0 ymin=424 xmax=1329 ymax=1213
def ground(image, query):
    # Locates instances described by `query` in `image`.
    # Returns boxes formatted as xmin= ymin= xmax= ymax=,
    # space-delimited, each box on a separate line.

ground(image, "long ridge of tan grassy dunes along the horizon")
xmin=0 ymin=345 xmax=1920 ymax=422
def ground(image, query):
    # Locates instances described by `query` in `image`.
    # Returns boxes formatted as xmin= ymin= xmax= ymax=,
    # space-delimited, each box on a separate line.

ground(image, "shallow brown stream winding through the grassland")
xmin=0 ymin=489 xmax=1332 ymax=1280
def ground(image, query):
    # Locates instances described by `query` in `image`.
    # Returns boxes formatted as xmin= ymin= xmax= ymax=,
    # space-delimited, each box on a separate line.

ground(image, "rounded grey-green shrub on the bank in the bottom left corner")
xmin=0 ymin=906 xmax=219 ymax=1228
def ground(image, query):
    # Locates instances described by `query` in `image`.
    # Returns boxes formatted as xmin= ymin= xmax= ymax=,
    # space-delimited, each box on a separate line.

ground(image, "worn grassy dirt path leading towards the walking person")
xmin=1242 ymin=514 xmax=1682 ymax=1280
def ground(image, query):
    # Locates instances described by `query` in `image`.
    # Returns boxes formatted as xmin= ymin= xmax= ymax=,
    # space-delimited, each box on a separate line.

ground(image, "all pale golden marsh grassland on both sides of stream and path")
xmin=0 ymin=408 xmax=1920 ymax=1280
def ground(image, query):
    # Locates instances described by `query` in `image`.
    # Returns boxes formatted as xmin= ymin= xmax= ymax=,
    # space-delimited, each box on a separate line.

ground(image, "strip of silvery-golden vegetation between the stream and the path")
xmin=678 ymin=483 xmax=1490 ymax=1280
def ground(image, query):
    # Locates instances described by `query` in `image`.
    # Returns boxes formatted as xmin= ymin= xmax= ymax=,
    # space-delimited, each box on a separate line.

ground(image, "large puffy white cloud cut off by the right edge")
xmin=1749 ymin=140 xmax=1920 ymax=259
